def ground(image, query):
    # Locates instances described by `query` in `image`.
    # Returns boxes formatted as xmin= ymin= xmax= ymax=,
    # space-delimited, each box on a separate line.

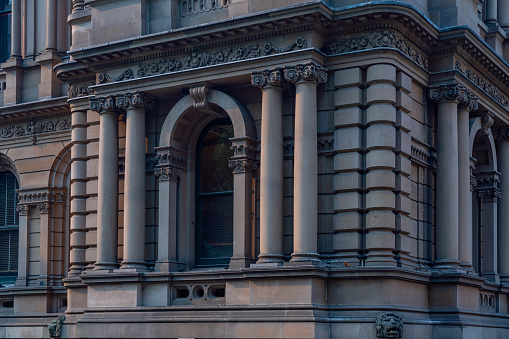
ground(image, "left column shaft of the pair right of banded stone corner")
xmin=436 ymin=100 xmax=459 ymax=266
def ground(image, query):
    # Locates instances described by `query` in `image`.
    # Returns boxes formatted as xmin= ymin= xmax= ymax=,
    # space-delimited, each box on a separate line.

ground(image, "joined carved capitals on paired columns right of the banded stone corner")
xmin=428 ymin=82 xmax=479 ymax=112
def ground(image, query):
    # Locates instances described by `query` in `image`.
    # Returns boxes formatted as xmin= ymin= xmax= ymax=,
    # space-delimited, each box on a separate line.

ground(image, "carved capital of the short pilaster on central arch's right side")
xmin=229 ymin=138 xmax=258 ymax=174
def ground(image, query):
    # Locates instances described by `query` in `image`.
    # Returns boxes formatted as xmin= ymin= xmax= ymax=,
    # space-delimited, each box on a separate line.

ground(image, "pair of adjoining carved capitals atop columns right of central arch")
xmin=251 ymin=62 xmax=327 ymax=88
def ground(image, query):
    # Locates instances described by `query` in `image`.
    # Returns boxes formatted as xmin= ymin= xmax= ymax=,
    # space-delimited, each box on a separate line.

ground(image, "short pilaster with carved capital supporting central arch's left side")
xmin=154 ymin=146 xmax=187 ymax=272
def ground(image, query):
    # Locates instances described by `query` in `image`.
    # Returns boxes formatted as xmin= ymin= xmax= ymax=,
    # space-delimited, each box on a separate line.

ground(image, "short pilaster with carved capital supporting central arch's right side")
xmin=229 ymin=136 xmax=256 ymax=268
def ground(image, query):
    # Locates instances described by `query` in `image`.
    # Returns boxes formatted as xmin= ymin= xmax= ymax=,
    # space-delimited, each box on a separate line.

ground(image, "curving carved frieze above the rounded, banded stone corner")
xmin=322 ymin=30 xmax=428 ymax=69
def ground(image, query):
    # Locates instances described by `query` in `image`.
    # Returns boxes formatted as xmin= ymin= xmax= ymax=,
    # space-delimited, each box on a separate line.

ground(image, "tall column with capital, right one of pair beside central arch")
xmin=285 ymin=62 xmax=327 ymax=262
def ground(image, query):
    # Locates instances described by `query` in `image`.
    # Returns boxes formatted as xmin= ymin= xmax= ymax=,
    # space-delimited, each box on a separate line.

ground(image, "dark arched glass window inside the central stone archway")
xmin=195 ymin=118 xmax=233 ymax=267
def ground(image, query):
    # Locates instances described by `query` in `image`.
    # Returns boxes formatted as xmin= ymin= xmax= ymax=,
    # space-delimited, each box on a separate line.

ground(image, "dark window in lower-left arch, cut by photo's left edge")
xmin=0 ymin=172 xmax=19 ymax=284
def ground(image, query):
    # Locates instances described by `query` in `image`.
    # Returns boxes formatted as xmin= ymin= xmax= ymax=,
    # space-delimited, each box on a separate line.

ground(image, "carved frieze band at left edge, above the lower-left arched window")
xmin=0 ymin=118 xmax=72 ymax=139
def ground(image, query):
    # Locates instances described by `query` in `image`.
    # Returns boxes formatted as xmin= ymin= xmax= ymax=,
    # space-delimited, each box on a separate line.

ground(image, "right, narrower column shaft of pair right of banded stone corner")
xmin=458 ymin=107 xmax=472 ymax=270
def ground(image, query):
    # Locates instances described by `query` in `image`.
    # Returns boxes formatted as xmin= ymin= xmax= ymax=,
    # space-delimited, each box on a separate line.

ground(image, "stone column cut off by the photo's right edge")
xmin=497 ymin=128 xmax=509 ymax=283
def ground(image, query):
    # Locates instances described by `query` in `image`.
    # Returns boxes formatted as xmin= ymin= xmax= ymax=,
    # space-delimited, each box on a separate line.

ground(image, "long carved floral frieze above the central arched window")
xmin=97 ymin=37 xmax=307 ymax=84
